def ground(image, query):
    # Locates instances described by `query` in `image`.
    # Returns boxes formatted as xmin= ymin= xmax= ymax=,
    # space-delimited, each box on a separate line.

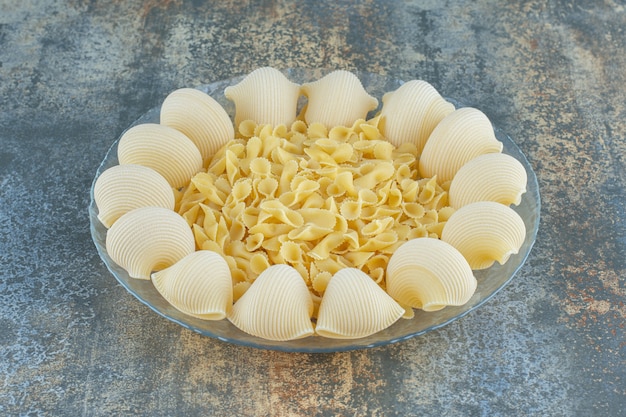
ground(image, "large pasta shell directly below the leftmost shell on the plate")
xmin=106 ymin=207 xmax=196 ymax=279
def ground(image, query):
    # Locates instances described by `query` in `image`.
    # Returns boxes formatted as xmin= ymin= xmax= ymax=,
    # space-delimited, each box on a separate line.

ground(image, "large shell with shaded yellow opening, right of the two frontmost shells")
xmin=387 ymin=238 xmax=477 ymax=311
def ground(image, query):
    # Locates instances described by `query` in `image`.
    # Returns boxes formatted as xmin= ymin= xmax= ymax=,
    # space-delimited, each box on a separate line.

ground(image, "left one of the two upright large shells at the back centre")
xmin=224 ymin=67 xmax=300 ymax=126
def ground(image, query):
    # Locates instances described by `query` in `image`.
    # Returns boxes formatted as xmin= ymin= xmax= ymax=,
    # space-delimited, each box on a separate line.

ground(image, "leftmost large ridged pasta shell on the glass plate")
xmin=93 ymin=164 xmax=175 ymax=228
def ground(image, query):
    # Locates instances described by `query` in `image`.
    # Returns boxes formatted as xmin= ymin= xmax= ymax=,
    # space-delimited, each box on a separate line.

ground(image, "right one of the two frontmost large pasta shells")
xmin=315 ymin=268 xmax=404 ymax=339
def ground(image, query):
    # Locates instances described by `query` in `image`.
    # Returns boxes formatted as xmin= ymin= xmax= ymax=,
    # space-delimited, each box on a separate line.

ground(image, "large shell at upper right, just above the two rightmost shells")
xmin=419 ymin=107 xmax=502 ymax=183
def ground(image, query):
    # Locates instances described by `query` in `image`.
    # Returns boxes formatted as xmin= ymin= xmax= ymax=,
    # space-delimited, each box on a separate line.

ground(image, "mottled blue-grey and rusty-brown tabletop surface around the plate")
xmin=0 ymin=0 xmax=626 ymax=416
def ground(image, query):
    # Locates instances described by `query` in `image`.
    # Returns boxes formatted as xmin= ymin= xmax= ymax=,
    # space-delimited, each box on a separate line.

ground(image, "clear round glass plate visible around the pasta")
xmin=89 ymin=69 xmax=540 ymax=352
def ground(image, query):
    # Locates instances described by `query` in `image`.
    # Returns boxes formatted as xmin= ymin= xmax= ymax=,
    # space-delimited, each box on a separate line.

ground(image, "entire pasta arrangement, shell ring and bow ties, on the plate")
xmin=94 ymin=67 xmax=527 ymax=341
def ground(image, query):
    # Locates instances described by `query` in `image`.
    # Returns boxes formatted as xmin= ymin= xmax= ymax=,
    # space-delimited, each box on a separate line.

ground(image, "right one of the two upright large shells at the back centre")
xmin=302 ymin=70 xmax=378 ymax=128
